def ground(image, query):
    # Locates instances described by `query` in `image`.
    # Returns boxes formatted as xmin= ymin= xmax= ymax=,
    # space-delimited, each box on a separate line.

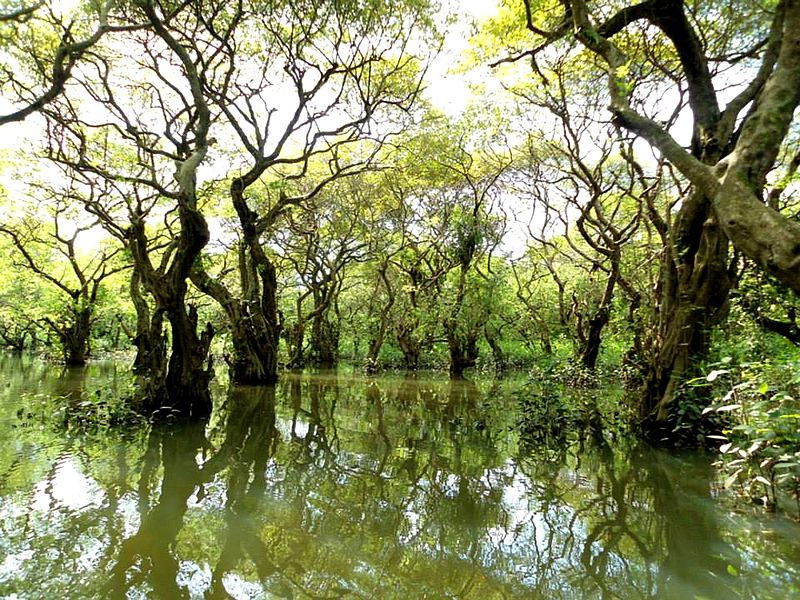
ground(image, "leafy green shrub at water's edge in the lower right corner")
xmin=703 ymin=359 xmax=800 ymax=517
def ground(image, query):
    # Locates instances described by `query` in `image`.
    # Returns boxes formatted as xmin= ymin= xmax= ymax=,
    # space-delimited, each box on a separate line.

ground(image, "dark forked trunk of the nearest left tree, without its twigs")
xmin=126 ymin=3 xmax=214 ymax=418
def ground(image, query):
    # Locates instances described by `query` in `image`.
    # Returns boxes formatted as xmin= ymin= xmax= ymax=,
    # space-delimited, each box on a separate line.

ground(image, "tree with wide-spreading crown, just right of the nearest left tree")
xmin=189 ymin=1 xmax=438 ymax=383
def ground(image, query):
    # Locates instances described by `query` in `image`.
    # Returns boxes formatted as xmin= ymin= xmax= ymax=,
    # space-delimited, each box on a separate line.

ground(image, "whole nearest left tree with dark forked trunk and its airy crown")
xmin=42 ymin=1 xmax=222 ymax=415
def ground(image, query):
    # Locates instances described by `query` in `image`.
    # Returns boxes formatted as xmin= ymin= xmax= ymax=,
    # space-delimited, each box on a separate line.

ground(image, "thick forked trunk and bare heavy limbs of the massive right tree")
xmin=571 ymin=0 xmax=800 ymax=430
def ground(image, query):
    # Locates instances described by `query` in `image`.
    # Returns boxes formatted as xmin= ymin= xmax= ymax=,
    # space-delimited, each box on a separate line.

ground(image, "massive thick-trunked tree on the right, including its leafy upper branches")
xmin=488 ymin=0 xmax=800 ymax=430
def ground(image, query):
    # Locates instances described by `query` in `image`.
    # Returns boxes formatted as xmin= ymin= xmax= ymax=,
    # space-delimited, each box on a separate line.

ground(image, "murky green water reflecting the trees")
xmin=0 ymin=358 xmax=800 ymax=600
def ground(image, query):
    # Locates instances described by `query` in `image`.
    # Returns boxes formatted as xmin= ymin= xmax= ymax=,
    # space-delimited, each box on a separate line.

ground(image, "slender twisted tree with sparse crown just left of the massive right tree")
xmin=515 ymin=113 xmax=642 ymax=370
